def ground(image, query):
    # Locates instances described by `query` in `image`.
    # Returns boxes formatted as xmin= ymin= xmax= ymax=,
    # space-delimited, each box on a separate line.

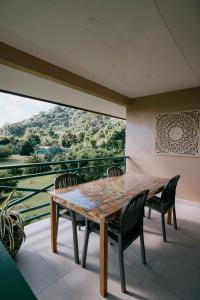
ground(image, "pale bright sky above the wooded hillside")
xmin=0 ymin=92 xmax=55 ymax=127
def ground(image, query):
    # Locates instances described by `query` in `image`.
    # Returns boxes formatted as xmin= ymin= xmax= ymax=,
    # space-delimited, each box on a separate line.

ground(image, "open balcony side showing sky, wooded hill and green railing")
xmin=0 ymin=92 xmax=125 ymax=224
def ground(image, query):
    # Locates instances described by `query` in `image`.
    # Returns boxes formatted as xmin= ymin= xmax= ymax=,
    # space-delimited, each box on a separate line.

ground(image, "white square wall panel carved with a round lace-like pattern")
xmin=155 ymin=110 xmax=200 ymax=156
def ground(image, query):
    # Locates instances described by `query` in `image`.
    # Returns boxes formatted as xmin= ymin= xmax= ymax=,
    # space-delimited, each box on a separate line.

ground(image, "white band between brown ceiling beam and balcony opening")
xmin=0 ymin=65 xmax=126 ymax=119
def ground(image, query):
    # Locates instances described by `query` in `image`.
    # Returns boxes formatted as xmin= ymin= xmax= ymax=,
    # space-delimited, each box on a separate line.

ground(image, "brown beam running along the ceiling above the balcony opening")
xmin=0 ymin=42 xmax=130 ymax=105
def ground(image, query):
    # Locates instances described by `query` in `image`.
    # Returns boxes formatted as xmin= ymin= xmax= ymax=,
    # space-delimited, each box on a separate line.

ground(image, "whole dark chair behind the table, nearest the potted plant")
xmin=54 ymin=173 xmax=85 ymax=264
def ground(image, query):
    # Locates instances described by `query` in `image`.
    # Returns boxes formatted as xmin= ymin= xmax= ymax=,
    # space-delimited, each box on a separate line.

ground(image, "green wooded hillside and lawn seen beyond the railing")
xmin=0 ymin=106 xmax=125 ymax=221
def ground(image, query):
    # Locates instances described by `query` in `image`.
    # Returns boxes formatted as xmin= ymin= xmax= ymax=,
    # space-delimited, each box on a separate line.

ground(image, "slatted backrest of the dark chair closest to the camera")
xmin=119 ymin=190 xmax=149 ymax=238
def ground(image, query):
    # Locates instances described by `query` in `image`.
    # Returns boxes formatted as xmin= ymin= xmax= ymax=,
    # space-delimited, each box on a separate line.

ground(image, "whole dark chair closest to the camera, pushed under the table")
xmin=82 ymin=191 xmax=148 ymax=293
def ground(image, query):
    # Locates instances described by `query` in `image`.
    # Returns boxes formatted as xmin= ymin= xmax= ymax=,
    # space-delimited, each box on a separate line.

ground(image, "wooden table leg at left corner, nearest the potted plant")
xmin=51 ymin=198 xmax=57 ymax=253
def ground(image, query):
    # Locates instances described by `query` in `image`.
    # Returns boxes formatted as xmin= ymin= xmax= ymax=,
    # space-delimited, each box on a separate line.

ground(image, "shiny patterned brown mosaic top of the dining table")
xmin=49 ymin=173 xmax=169 ymax=223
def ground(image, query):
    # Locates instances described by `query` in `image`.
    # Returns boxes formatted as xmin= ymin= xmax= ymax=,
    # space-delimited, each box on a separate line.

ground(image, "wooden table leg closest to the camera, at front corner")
xmin=100 ymin=223 xmax=108 ymax=297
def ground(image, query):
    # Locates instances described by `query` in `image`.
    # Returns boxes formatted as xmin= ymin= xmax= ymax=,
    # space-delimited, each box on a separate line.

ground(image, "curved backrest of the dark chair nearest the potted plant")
xmin=54 ymin=173 xmax=80 ymax=189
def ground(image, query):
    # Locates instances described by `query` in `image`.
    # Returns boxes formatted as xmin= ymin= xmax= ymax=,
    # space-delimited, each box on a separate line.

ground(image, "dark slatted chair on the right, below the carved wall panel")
xmin=145 ymin=175 xmax=180 ymax=242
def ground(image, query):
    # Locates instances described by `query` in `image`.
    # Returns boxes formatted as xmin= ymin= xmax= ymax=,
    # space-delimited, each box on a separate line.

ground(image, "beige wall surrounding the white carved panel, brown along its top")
xmin=126 ymin=88 xmax=200 ymax=202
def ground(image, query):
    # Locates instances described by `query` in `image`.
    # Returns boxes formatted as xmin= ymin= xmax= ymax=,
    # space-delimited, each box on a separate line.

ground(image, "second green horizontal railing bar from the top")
xmin=0 ymin=162 xmax=120 ymax=180
